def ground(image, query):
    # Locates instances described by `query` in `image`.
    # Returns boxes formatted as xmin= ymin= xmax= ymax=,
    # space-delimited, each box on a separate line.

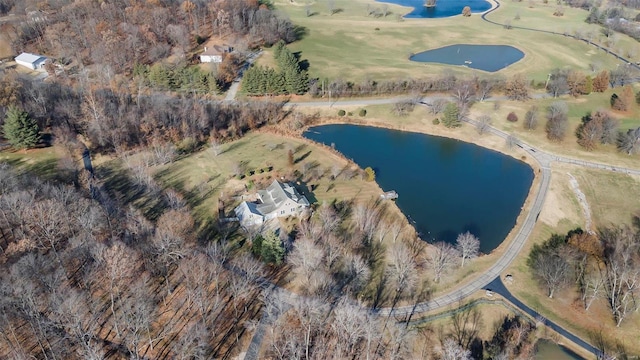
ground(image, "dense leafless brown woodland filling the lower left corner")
xmin=0 ymin=164 xmax=265 ymax=359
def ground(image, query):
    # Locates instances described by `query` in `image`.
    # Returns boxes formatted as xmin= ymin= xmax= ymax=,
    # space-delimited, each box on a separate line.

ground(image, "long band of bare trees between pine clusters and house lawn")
xmin=0 ymin=74 xmax=286 ymax=152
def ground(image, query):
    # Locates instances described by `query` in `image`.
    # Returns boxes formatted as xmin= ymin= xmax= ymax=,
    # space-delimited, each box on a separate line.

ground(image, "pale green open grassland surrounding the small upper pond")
xmin=260 ymin=0 xmax=626 ymax=82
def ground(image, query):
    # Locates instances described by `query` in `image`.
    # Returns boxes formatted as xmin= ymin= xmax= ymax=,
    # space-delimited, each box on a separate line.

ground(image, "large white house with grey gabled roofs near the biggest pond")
xmin=234 ymin=180 xmax=309 ymax=226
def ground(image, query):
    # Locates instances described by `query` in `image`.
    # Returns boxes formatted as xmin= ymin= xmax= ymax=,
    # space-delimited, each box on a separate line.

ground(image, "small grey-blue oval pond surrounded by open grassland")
xmin=409 ymin=44 xmax=524 ymax=72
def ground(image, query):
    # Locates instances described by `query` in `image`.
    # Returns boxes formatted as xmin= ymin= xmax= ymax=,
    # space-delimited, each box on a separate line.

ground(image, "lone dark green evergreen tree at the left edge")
xmin=2 ymin=106 xmax=40 ymax=149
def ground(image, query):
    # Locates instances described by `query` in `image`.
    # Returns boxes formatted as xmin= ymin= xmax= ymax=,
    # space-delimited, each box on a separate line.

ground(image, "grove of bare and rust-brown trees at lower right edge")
xmin=527 ymin=224 xmax=640 ymax=326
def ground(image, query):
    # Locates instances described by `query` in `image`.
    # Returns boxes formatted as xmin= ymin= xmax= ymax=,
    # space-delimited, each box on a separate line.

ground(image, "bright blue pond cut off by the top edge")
xmin=378 ymin=0 xmax=491 ymax=18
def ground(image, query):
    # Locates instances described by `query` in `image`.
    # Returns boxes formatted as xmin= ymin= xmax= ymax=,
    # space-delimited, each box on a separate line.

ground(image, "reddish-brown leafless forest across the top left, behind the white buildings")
xmin=5 ymin=0 xmax=299 ymax=80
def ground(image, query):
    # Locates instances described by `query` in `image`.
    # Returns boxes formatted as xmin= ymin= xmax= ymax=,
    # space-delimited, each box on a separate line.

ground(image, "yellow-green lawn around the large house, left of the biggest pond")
xmin=156 ymin=132 xmax=381 ymax=222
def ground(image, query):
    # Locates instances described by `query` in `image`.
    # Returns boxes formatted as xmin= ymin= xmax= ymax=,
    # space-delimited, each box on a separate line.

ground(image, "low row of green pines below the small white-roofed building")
xmin=133 ymin=63 xmax=218 ymax=94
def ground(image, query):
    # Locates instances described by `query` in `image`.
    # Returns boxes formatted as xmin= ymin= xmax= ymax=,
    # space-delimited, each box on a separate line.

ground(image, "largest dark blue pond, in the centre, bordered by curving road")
xmin=304 ymin=125 xmax=533 ymax=253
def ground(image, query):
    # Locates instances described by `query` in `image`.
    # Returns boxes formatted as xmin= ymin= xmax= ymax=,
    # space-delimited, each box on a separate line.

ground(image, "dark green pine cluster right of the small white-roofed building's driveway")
xmin=242 ymin=41 xmax=309 ymax=95
